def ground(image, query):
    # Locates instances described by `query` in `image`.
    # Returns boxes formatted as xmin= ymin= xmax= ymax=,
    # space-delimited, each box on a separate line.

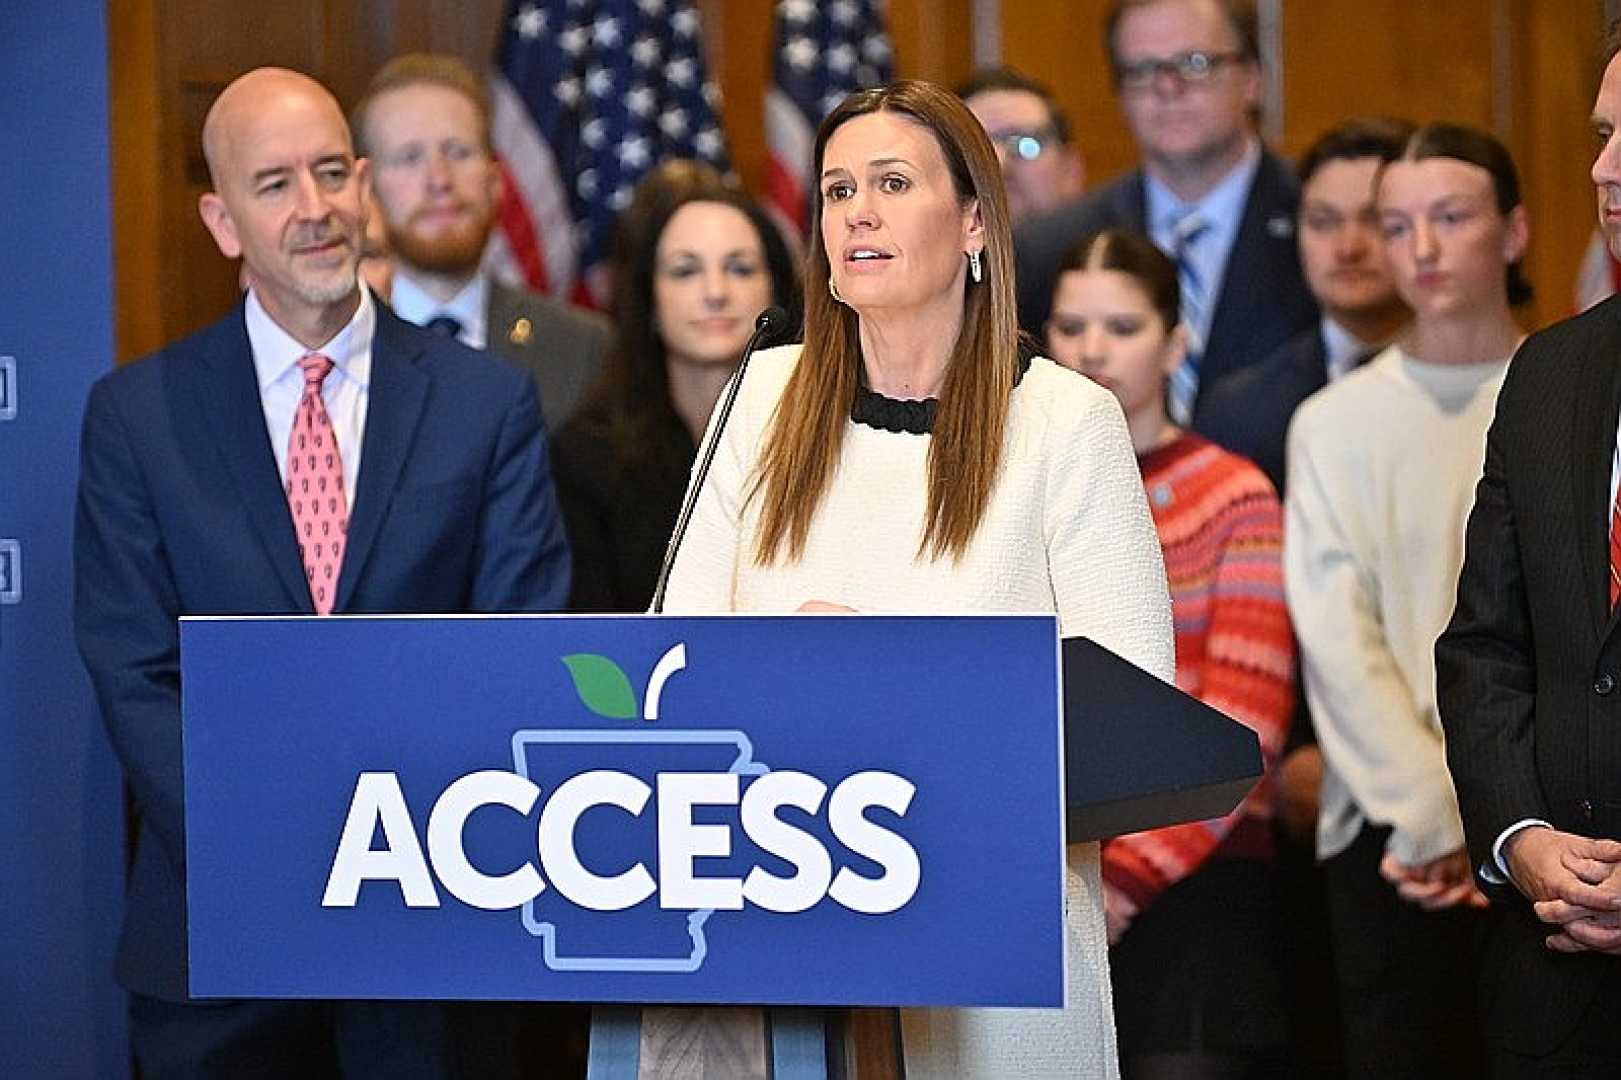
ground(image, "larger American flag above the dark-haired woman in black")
xmin=485 ymin=0 xmax=729 ymax=306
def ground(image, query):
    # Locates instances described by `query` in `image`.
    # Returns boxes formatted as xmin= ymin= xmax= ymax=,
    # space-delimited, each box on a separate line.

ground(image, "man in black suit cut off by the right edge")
xmin=1435 ymin=26 xmax=1621 ymax=1077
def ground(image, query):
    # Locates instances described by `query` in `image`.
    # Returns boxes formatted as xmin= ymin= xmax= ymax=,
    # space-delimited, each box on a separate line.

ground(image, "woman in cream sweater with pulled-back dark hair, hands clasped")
xmin=1284 ymin=125 xmax=1530 ymax=1077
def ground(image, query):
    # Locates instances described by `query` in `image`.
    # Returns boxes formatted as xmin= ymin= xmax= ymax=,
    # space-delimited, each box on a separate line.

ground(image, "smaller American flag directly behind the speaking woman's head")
xmin=765 ymin=0 xmax=893 ymax=237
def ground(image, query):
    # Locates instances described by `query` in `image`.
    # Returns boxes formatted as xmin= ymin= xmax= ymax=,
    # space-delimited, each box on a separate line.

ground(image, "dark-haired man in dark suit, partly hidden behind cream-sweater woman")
xmin=1200 ymin=120 xmax=1414 ymax=495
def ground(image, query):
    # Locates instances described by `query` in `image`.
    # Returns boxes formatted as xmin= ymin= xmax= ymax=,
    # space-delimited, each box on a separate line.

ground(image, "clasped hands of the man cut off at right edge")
xmin=1503 ymin=825 xmax=1621 ymax=955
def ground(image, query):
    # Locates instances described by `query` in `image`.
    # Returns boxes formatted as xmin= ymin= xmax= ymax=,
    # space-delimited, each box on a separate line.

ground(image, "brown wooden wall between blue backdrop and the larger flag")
xmin=107 ymin=0 xmax=503 ymax=362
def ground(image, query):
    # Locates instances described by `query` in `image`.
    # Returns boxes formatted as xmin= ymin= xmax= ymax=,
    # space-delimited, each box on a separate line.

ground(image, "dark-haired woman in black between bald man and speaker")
xmin=553 ymin=178 xmax=798 ymax=611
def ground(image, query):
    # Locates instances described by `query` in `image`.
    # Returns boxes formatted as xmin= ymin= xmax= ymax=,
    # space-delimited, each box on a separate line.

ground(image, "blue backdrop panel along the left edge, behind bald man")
xmin=0 ymin=0 xmax=128 ymax=1078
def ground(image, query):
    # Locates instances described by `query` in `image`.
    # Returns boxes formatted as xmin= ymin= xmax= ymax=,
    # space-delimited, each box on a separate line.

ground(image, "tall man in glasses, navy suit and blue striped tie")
xmin=1013 ymin=0 xmax=1316 ymax=428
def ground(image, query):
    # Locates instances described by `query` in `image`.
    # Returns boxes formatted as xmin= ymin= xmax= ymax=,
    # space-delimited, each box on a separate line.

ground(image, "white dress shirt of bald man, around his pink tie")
xmin=246 ymin=289 xmax=378 ymax=509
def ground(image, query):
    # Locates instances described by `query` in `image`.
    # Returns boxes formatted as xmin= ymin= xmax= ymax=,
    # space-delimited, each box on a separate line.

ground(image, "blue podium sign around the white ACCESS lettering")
xmin=182 ymin=616 xmax=1063 ymax=1005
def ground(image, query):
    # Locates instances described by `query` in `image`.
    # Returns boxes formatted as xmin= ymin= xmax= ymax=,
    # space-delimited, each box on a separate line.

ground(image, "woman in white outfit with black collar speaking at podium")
xmin=666 ymin=81 xmax=1174 ymax=1080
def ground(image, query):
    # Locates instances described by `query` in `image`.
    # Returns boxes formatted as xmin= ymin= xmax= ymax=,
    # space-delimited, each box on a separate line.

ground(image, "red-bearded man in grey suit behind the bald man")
xmin=355 ymin=54 xmax=608 ymax=431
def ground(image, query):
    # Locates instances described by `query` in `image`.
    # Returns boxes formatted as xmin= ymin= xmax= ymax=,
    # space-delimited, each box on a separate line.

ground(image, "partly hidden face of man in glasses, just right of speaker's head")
xmin=956 ymin=68 xmax=1086 ymax=225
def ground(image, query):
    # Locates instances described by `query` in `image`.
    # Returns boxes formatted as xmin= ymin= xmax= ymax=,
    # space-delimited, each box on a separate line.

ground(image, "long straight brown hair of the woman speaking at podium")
xmin=749 ymin=81 xmax=1018 ymax=564
